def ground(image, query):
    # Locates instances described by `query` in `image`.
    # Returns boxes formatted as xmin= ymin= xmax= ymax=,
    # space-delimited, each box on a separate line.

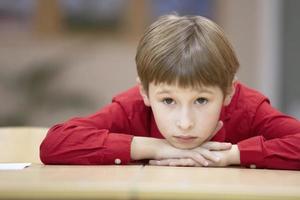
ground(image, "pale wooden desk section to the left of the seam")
xmin=0 ymin=164 xmax=142 ymax=200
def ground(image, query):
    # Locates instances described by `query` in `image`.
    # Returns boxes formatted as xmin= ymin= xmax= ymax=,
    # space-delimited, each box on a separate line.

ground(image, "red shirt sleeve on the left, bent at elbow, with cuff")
xmin=40 ymin=102 xmax=133 ymax=165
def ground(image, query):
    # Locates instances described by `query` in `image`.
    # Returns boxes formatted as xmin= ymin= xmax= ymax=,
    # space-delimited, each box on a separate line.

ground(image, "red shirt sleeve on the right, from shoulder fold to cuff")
xmin=238 ymin=99 xmax=300 ymax=170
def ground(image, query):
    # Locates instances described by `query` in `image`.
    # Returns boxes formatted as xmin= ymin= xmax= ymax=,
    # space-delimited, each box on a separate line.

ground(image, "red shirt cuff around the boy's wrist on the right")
xmin=237 ymin=136 xmax=264 ymax=168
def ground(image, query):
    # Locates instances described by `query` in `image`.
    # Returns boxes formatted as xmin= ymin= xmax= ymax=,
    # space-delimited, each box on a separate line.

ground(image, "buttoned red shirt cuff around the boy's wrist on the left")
xmin=102 ymin=133 xmax=133 ymax=165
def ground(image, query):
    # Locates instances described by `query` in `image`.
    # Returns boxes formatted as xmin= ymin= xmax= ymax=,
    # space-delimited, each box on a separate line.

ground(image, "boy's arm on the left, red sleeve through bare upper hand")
xmin=40 ymin=99 xmax=229 ymax=165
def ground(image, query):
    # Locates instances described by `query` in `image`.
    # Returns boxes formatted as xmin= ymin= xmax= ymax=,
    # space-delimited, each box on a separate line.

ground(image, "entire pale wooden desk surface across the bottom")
xmin=0 ymin=164 xmax=300 ymax=200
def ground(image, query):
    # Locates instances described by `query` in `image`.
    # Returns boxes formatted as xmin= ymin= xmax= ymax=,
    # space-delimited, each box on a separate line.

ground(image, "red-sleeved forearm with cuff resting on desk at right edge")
xmin=238 ymin=133 xmax=300 ymax=170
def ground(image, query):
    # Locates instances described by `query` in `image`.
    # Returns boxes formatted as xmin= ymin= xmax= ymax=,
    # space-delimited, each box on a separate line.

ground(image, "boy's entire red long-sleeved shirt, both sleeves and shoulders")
xmin=40 ymin=83 xmax=300 ymax=169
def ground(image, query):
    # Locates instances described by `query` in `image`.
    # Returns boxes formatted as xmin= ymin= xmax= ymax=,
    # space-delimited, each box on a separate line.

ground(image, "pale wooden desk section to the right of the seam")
xmin=134 ymin=166 xmax=300 ymax=200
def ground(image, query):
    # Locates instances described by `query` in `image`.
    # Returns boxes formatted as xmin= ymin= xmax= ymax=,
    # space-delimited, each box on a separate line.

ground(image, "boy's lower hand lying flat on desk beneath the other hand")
xmin=149 ymin=145 xmax=240 ymax=167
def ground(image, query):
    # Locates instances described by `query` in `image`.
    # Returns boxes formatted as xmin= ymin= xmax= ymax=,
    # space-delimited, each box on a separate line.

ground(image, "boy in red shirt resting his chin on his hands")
xmin=40 ymin=15 xmax=300 ymax=169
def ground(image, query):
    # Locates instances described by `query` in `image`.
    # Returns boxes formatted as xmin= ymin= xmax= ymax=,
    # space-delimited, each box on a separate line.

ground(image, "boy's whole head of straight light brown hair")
xmin=136 ymin=15 xmax=239 ymax=96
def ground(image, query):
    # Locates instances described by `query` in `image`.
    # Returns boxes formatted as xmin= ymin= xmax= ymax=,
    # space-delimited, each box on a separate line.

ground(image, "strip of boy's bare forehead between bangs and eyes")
xmin=149 ymin=83 xmax=222 ymax=95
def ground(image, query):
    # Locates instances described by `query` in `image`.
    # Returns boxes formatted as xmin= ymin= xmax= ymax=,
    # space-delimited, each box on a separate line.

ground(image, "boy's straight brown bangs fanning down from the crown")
xmin=148 ymin=32 xmax=228 ymax=93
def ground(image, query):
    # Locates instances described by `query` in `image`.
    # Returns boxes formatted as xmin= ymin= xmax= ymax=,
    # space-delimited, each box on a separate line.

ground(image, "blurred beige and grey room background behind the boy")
xmin=0 ymin=0 xmax=300 ymax=126
